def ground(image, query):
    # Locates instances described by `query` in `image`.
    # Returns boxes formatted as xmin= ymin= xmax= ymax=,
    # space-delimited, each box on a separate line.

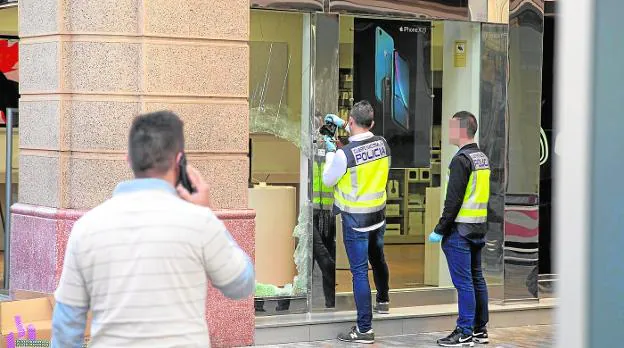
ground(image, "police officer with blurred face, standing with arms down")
xmin=429 ymin=111 xmax=490 ymax=347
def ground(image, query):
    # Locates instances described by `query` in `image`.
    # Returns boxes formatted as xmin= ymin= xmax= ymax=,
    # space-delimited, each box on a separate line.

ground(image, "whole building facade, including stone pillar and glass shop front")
xmin=0 ymin=0 xmax=548 ymax=346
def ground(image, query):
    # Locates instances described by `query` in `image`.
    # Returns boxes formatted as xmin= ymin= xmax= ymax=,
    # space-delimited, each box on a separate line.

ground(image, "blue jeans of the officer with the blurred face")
xmin=442 ymin=231 xmax=489 ymax=334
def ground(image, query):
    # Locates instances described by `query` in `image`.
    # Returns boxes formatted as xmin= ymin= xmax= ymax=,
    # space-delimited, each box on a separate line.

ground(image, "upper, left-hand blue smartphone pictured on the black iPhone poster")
xmin=375 ymin=27 xmax=394 ymax=103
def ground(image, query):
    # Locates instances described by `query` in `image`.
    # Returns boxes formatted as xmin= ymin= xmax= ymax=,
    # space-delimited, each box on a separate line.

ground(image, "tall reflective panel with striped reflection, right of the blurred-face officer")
xmin=504 ymin=0 xmax=544 ymax=300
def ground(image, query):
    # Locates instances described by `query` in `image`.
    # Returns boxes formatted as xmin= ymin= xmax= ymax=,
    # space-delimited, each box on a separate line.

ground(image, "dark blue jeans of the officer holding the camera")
xmin=342 ymin=214 xmax=389 ymax=332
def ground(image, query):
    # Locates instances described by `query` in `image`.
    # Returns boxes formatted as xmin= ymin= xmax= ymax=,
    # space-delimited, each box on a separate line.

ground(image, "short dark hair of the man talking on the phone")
xmin=128 ymin=111 xmax=184 ymax=177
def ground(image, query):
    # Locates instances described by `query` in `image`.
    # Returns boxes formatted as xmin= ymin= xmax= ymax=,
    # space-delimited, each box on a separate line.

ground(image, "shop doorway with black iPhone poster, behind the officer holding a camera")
xmin=336 ymin=16 xmax=439 ymax=301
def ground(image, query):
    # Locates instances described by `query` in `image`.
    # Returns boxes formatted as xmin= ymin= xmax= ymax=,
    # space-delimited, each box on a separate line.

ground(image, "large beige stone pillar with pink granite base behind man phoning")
xmin=10 ymin=0 xmax=254 ymax=346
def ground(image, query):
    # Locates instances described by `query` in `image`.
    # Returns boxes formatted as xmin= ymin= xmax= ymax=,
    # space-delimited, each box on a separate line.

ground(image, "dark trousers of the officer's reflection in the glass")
xmin=312 ymin=209 xmax=336 ymax=308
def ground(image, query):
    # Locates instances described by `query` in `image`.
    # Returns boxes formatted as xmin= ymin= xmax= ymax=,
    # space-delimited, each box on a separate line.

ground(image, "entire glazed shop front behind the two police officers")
xmin=249 ymin=10 xmax=506 ymax=315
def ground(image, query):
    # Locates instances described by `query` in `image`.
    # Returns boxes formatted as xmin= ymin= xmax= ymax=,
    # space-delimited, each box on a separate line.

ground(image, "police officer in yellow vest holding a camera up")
xmin=323 ymin=101 xmax=390 ymax=343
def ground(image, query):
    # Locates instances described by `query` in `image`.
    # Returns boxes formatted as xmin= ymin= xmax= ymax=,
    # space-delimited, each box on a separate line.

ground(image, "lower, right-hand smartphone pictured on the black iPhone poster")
xmin=392 ymin=52 xmax=410 ymax=130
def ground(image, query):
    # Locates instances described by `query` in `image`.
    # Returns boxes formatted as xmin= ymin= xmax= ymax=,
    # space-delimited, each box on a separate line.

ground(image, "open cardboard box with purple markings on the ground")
xmin=0 ymin=291 xmax=91 ymax=348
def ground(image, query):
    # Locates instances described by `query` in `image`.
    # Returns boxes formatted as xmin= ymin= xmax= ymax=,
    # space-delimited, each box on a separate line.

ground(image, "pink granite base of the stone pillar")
xmin=10 ymin=204 xmax=255 ymax=347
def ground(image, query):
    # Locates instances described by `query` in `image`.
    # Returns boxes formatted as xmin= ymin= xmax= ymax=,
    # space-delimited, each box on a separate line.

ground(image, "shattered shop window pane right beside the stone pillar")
xmin=249 ymin=10 xmax=311 ymax=315
